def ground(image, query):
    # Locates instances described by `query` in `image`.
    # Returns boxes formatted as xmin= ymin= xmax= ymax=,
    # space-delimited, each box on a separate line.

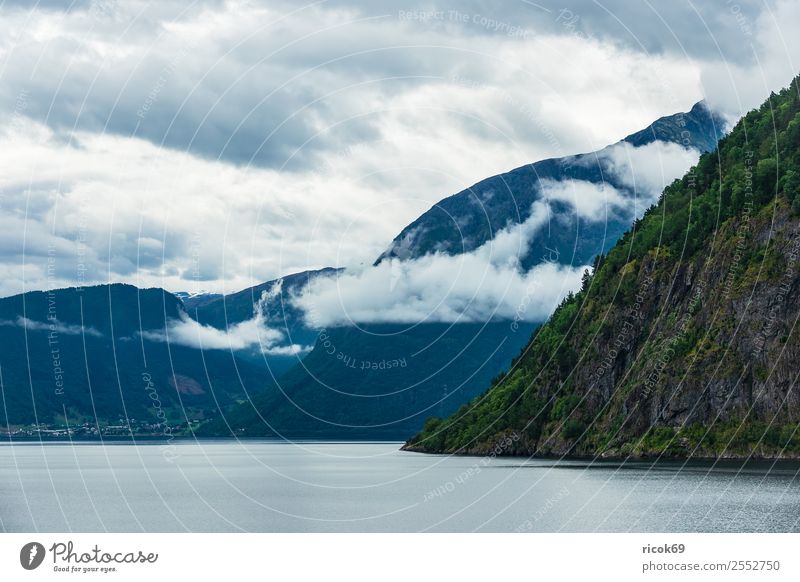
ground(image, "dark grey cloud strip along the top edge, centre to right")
xmin=336 ymin=0 xmax=774 ymax=61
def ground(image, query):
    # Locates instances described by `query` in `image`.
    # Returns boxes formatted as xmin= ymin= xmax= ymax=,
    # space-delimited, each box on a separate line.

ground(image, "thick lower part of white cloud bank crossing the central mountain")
xmin=291 ymin=212 xmax=588 ymax=327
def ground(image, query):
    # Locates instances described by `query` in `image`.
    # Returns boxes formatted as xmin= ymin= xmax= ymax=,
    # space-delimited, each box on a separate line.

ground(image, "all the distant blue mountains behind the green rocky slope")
xmin=0 ymin=104 xmax=722 ymax=438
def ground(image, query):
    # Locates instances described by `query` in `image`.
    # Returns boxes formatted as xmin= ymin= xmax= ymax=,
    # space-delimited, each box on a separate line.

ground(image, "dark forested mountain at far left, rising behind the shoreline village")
xmin=0 ymin=284 xmax=266 ymax=432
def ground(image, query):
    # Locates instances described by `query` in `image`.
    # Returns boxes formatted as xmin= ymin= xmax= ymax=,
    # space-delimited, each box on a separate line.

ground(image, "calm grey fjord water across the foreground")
xmin=0 ymin=441 xmax=800 ymax=532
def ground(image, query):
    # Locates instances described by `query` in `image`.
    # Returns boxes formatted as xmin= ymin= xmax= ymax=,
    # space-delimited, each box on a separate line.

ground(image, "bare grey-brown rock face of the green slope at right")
xmin=536 ymin=200 xmax=800 ymax=456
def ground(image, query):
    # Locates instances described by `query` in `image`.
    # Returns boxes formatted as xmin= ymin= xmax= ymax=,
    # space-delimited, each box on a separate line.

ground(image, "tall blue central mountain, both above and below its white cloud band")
xmin=203 ymin=103 xmax=722 ymax=438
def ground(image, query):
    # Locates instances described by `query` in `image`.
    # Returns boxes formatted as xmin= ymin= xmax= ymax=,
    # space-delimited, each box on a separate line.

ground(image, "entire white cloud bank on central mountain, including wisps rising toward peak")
xmin=293 ymin=141 xmax=700 ymax=327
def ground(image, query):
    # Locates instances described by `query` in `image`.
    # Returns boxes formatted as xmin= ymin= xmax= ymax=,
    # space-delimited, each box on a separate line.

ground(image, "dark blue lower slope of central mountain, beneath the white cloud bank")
xmin=199 ymin=322 xmax=535 ymax=439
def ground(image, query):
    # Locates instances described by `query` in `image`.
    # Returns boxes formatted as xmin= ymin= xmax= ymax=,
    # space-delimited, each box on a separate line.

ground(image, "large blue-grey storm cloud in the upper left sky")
xmin=0 ymin=4 xmax=460 ymax=169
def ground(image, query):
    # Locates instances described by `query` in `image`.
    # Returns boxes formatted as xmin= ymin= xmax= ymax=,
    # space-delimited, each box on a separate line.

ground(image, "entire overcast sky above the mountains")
xmin=0 ymin=0 xmax=800 ymax=295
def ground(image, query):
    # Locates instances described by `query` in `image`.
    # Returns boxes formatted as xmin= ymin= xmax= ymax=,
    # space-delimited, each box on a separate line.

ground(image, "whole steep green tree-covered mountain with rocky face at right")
xmin=405 ymin=79 xmax=800 ymax=457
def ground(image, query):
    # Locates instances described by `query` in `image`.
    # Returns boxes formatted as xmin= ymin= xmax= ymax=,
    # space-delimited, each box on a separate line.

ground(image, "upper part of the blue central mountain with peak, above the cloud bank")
xmin=377 ymin=102 xmax=725 ymax=268
